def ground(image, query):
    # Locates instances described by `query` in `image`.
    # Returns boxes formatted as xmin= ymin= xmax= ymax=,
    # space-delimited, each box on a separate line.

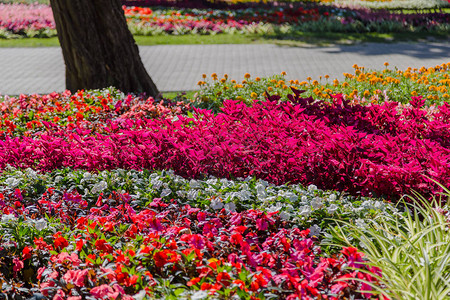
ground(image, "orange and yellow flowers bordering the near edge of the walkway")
xmin=195 ymin=62 xmax=450 ymax=106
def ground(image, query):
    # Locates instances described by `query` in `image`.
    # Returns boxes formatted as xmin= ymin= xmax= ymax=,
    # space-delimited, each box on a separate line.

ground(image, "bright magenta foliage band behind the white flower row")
xmin=0 ymin=89 xmax=450 ymax=198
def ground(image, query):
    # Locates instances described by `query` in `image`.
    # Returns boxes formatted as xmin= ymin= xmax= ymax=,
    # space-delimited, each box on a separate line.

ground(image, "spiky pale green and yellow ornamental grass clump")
xmin=331 ymin=186 xmax=450 ymax=300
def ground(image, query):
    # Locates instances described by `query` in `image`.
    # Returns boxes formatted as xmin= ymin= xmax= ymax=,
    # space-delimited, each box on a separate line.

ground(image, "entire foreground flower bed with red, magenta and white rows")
xmin=0 ymin=67 xmax=450 ymax=300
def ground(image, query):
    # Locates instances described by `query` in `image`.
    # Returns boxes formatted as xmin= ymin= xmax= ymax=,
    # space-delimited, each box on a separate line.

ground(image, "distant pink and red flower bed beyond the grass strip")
xmin=0 ymin=3 xmax=449 ymax=38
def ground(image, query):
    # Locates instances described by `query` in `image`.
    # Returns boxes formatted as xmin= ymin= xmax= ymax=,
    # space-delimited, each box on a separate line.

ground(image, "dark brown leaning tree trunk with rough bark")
xmin=50 ymin=0 xmax=159 ymax=97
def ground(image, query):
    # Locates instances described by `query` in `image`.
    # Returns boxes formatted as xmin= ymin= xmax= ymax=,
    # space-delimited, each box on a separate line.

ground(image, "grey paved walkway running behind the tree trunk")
xmin=0 ymin=42 xmax=450 ymax=95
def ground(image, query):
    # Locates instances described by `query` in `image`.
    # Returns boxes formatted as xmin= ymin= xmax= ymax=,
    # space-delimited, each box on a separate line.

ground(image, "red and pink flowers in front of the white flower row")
xmin=0 ymin=184 xmax=380 ymax=299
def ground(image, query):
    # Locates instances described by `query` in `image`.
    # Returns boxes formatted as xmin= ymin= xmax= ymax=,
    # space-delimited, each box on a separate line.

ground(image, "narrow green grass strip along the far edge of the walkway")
xmin=0 ymin=32 xmax=449 ymax=48
